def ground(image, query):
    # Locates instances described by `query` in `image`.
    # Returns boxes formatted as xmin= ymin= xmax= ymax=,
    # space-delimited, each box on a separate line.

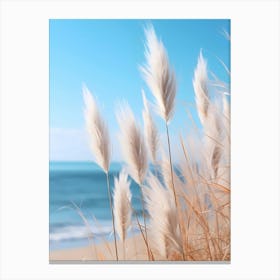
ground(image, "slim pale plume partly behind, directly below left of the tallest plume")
xmin=142 ymin=91 xmax=159 ymax=164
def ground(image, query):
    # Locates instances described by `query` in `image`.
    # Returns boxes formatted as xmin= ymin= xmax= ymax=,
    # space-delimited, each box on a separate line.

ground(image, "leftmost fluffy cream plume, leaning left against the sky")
xmin=83 ymin=86 xmax=110 ymax=173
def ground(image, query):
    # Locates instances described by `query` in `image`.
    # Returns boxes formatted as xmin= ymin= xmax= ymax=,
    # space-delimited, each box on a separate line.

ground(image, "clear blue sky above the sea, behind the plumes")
xmin=49 ymin=20 xmax=230 ymax=161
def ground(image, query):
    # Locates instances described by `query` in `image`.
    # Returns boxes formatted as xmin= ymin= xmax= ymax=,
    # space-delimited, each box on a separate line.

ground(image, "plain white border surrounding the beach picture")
xmin=0 ymin=0 xmax=280 ymax=279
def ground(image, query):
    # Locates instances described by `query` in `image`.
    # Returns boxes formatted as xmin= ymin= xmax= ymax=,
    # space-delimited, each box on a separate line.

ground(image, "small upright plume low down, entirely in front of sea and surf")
xmin=114 ymin=170 xmax=132 ymax=242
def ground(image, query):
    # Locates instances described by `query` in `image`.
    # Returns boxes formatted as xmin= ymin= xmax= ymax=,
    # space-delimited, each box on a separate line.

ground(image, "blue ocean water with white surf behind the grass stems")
xmin=49 ymin=162 xmax=142 ymax=250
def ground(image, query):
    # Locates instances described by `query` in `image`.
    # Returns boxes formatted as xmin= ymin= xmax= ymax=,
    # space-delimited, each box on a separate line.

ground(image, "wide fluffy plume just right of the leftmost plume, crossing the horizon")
xmin=117 ymin=104 xmax=148 ymax=185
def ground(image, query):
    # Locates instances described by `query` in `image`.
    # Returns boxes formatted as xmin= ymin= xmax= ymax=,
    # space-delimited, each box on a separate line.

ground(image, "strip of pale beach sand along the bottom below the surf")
xmin=49 ymin=235 xmax=154 ymax=263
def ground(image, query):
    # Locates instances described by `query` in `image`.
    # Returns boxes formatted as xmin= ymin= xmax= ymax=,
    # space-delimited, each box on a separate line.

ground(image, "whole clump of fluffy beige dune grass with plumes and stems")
xmin=80 ymin=26 xmax=230 ymax=261
